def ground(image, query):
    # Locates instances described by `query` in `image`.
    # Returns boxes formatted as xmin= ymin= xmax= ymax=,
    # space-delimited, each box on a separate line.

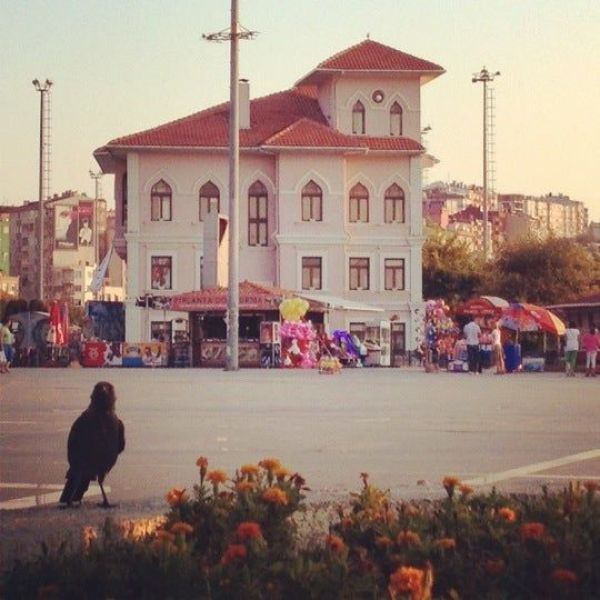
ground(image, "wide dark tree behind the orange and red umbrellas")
xmin=482 ymin=233 xmax=600 ymax=304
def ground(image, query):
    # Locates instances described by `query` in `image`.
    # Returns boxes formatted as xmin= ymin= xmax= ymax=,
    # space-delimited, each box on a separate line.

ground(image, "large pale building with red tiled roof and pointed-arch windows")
xmin=94 ymin=39 xmax=444 ymax=358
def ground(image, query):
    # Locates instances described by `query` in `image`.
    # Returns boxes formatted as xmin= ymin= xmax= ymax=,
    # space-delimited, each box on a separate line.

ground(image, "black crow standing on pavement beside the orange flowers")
xmin=59 ymin=381 xmax=125 ymax=508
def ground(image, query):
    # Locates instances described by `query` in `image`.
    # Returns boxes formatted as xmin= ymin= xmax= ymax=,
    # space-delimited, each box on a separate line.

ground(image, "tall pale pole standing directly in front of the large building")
xmin=202 ymin=0 xmax=256 ymax=371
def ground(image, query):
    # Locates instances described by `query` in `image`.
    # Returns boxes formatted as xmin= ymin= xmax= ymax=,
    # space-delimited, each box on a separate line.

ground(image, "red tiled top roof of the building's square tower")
xmin=317 ymin=40 xmax=444 ymax=73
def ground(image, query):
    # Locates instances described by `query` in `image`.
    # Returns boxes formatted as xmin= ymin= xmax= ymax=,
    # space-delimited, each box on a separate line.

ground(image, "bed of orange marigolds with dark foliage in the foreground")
xmin=0 ymin=457 xmax=600 ymax=600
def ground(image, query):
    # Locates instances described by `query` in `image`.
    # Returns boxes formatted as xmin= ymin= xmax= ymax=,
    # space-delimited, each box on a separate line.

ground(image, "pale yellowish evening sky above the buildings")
xmin=0 ymin=0 xmax=600 ymax=221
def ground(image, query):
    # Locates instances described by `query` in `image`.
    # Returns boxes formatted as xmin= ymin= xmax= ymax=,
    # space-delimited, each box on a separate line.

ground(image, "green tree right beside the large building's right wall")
xmin=423 ymin=227 xmax=482 ymax=306
